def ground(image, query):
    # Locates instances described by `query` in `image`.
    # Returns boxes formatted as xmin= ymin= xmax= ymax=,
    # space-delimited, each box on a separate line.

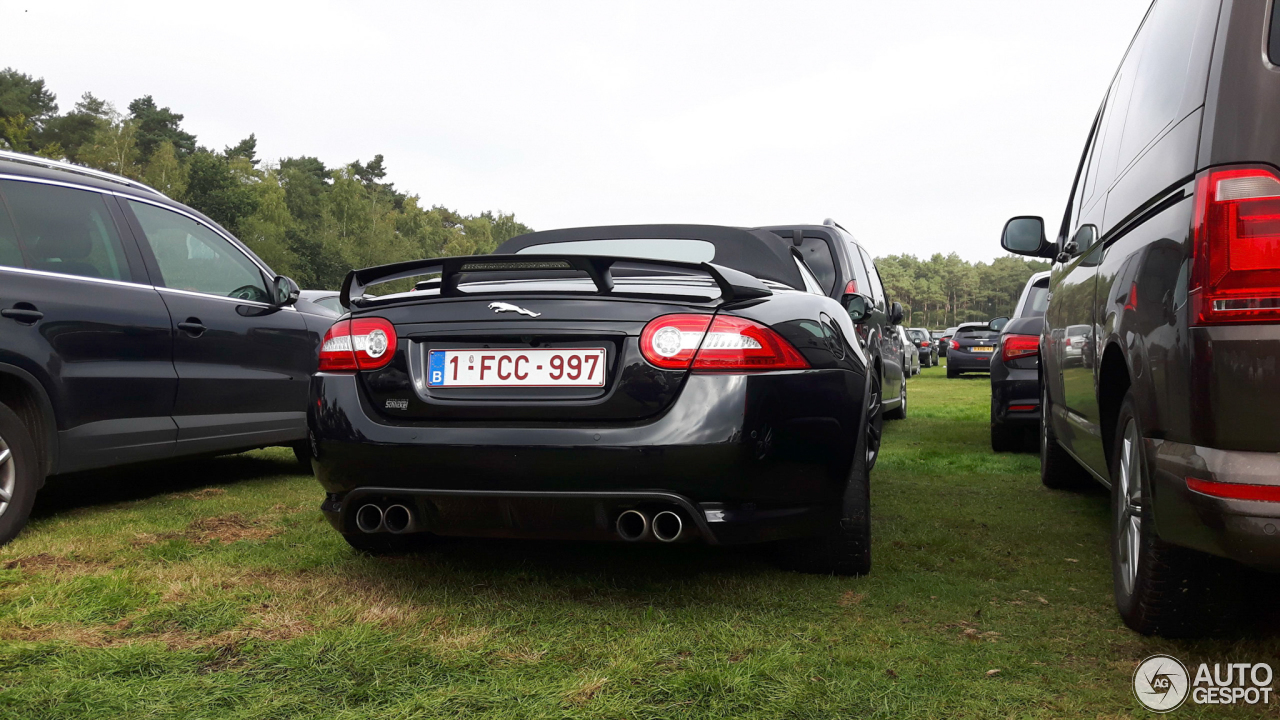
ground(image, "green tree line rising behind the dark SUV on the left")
xmin=0 ymin=68 xmax=530 ymax=288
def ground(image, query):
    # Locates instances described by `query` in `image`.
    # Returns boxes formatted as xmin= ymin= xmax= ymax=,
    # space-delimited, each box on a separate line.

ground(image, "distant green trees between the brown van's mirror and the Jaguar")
xmin=876 ymin=252 xmax=1048 ymax=328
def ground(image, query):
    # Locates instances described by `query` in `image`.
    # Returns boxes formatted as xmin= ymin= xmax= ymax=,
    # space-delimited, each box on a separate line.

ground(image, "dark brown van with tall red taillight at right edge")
xmin=1002 ymin=0 xmax=1280 ymax=635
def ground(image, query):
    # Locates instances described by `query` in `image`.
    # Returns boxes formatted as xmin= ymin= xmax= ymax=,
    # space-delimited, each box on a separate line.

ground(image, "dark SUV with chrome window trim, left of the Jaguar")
xmin=0 ymin=152 xmax=333 ymax=543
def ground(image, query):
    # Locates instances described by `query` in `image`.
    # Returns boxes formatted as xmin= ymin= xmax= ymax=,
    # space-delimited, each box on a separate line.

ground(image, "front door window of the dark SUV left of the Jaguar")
xmin=129 ymin=200 xmax=271 ymax=302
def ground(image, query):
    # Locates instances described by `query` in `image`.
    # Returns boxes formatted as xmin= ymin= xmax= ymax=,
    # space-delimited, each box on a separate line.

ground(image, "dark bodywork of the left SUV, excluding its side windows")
xmin=0 ymin=155 xmax=320 ymax=474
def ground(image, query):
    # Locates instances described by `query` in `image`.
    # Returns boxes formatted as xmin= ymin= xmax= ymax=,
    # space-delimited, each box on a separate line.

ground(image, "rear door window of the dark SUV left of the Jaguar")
xmin=0 ymin=181 xmax=133 ymax=282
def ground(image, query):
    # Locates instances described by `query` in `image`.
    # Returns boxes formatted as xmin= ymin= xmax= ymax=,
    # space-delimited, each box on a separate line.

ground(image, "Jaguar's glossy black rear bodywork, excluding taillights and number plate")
xmin=308 ymin=233 xmax=868 ymax=543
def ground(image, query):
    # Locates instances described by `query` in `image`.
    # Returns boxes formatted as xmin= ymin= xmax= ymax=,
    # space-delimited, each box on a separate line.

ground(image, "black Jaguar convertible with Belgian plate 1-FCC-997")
xmin=308 ymin=225 xmax=881 ymax=574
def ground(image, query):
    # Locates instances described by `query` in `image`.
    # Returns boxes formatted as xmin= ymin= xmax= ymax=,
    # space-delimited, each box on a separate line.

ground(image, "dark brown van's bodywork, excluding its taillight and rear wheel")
xmin=1003 ymin=0 xmax=1280 ymax=568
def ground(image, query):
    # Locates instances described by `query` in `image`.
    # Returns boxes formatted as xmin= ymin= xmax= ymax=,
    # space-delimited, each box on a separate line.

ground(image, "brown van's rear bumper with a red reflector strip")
xmin=1147 ymin=439 xmax=1280 ymax=570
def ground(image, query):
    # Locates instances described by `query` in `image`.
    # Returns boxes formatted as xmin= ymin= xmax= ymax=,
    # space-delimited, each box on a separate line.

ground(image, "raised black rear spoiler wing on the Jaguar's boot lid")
xmin=340 ymin=255 xmax=773 ymax=310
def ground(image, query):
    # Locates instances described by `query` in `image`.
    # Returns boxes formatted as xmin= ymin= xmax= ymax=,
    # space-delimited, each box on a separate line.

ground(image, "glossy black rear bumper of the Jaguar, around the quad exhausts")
xmin=308 ymin=370 xmax=865 ymax=543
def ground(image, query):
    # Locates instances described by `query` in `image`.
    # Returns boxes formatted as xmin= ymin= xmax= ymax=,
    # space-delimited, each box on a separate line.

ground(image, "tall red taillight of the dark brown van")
xmin=1188 ymin=168 xmax=1280 ymax=325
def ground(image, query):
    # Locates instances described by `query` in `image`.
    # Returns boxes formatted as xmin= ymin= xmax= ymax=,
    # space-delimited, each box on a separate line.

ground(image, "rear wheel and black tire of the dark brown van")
xmin=1111 ymin=392 xmax=1249 ymax=638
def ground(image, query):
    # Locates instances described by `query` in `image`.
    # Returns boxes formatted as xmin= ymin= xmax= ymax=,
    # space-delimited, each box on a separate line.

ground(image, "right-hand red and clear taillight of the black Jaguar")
xmin=640 ymin=315 xmax=809 ymax=373
